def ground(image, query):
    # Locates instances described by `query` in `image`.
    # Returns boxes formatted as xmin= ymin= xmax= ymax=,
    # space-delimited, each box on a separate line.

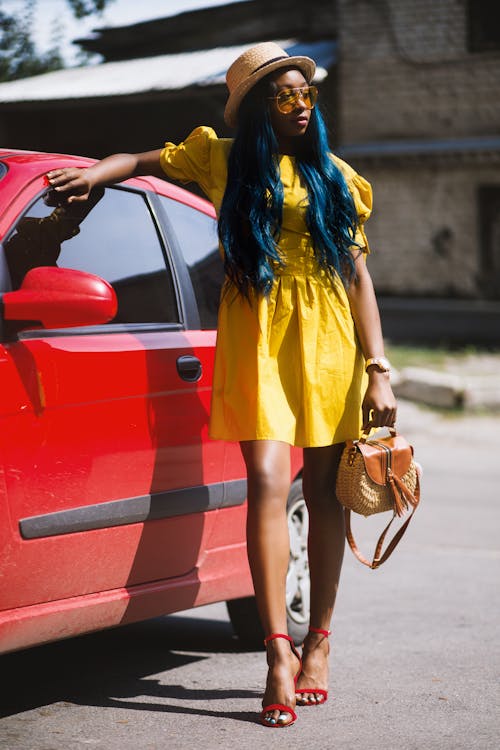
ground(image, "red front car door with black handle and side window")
xmin=0 ymin=176 xmax=223 ymax=609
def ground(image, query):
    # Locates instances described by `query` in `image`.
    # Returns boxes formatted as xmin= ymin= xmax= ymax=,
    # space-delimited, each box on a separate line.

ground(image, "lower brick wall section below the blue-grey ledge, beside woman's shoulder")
xmin=359 ymin=156 xmax=500 ymax=298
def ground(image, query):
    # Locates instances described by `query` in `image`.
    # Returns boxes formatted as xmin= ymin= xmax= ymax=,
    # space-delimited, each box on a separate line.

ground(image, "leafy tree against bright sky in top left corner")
xmin=0 ymin=0 xmax=113 ymax=81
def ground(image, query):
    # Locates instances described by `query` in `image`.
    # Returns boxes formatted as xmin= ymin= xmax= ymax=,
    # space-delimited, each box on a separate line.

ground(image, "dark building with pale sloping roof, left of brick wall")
xmin=0 ymin=0 xmax=336 ymax=158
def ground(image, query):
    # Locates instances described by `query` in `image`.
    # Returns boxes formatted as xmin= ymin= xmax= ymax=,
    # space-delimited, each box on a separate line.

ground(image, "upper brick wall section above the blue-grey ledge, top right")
xmin=339 ymin=0 xmax=500 ymax=143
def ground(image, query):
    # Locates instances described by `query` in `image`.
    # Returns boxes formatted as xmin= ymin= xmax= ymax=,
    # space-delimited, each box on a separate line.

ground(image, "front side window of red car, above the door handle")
xmin=4 ymin=188 xmax=179 ymax=323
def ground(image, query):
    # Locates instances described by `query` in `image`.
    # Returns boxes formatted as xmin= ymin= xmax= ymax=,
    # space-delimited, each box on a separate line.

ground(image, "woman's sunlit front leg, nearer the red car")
xmin=241 ymin=440 xmax=299 ymax=723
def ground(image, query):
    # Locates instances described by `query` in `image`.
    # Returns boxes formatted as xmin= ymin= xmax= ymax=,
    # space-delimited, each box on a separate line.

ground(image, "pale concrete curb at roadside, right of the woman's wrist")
xmin=392 ymin=367 xmax=500 ymax=411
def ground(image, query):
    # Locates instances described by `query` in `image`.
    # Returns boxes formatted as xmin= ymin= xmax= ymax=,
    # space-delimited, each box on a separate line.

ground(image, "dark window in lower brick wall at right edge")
xmin=478 ymin=185 xmax=500 ymax=299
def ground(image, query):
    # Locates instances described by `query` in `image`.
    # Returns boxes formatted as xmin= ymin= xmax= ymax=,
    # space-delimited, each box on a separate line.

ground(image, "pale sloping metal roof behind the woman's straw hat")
xmin=0 ymin=40 xmax=336 ymax=105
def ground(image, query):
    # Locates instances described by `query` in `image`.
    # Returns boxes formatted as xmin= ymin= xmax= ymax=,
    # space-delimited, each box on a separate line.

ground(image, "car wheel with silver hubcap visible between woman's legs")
xmin=226 ymin=479 xmax=310 ymax=648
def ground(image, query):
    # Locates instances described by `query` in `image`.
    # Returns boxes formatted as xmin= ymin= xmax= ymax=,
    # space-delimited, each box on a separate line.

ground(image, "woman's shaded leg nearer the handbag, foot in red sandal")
xmin=297 ymin=444 xmax=345 ymax=704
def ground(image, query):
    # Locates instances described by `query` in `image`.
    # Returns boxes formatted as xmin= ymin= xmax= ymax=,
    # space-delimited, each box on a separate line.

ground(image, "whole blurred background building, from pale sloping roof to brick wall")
xmin=0 ymin=0 xmax=500 ymax=345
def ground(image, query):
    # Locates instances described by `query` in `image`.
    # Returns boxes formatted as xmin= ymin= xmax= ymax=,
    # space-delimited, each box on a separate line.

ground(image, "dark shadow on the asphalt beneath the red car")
xmin=0 ymin=616 xmax=256 ymax=721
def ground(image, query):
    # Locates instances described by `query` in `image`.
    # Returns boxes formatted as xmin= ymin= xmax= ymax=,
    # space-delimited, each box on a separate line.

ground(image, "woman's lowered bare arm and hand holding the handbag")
xmin=347 ymin=249 xmax=396 ymax=430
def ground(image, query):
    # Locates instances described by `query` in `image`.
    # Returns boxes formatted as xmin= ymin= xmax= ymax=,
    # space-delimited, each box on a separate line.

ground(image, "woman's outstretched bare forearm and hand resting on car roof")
xmin=47 ymin=149 xmax=164 ymax=203
